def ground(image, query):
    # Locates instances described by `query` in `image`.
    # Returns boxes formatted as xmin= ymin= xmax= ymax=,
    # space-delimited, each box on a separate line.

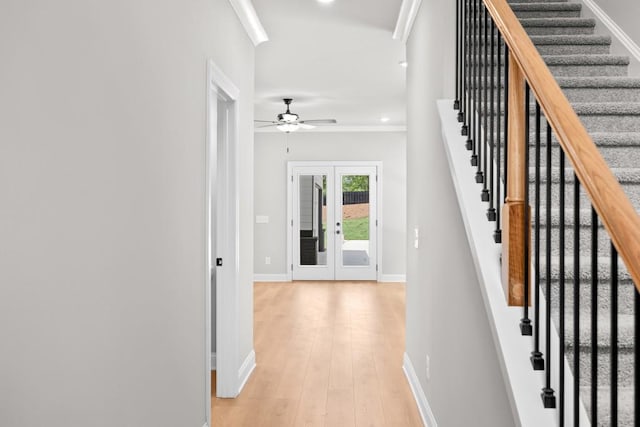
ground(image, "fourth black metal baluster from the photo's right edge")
xmin=573 ymin=173 xmax=580 ymax=427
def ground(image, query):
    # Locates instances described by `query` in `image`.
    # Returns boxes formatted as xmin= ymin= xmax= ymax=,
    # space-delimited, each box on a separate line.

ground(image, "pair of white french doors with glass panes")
xmin=290 ymin=162 xmax=378 ymax=280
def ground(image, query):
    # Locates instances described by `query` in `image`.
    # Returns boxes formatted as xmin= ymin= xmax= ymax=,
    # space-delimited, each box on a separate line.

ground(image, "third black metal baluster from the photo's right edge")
xmin=591 ymin=206 xmax=598 ymax=425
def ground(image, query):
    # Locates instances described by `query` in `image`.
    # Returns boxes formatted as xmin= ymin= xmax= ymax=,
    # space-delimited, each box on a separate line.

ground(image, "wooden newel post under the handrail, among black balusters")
xmin=502 ymin=55 xmax=531 ymax=306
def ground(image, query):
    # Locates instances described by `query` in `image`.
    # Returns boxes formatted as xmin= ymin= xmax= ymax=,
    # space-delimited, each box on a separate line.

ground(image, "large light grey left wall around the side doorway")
xmin=0 ymin=0 xmax=253 ymax=427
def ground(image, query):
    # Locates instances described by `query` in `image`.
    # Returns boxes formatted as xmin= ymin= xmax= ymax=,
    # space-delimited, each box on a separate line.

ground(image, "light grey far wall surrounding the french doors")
xmin=254 ymin=132 xmax=406 ymax=275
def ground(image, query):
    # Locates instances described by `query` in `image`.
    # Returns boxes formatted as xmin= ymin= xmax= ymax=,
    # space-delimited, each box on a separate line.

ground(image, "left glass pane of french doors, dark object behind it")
xmin=298 ymin=175 xmax=327 ymax=265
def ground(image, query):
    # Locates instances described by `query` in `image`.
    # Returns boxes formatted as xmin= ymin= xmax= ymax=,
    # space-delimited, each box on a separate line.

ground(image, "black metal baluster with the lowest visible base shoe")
xmin=542 ymin=122 xmax=556 ymax=408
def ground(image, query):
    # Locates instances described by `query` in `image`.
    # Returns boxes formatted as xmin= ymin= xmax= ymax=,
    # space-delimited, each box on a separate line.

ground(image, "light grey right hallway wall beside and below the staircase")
xmin=406 ymin=0 xmax=514 ymax=427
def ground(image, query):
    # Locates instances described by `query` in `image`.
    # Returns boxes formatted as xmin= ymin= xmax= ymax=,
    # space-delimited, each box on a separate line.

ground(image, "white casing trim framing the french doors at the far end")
xmin=287 ymin=160 xmax=384 ymax=281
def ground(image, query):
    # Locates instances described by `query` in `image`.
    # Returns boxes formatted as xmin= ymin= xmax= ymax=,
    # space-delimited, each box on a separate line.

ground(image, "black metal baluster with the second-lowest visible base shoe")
xmin=530 ymin=100 xmax=544 ymax=371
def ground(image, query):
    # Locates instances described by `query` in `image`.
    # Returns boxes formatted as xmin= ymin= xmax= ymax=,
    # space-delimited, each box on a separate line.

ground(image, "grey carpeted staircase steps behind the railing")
xmin=509 ymin=0 xmax=640 ymax=426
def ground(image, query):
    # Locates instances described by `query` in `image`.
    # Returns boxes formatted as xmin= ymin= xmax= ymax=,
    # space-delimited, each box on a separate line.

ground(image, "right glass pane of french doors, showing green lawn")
xmin=341 ymin=175 xmax=370 ymax=266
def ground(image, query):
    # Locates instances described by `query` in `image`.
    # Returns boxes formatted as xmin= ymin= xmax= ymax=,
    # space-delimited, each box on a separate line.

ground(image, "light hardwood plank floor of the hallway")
xmin=211 ymin=282 xmax=422 ymax=427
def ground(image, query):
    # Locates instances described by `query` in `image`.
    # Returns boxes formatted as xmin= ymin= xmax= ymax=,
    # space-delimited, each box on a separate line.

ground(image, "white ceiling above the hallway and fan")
xmin=253 ymin=0 xmax=406 ymax=132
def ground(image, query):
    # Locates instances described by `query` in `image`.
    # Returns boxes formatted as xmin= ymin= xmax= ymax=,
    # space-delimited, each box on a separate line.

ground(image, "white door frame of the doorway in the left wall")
xmin=205 ymin=59 xmax=240 ymax=410
